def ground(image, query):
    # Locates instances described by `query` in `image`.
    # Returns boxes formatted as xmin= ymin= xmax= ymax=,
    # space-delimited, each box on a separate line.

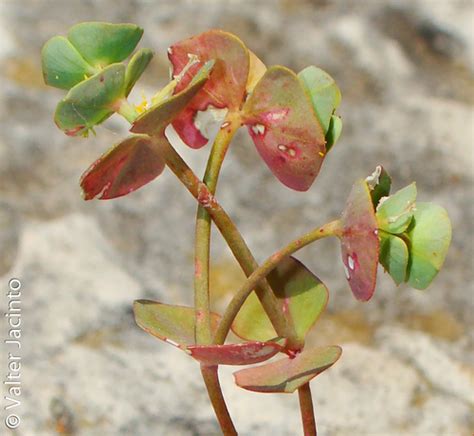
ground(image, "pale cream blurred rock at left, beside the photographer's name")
xmin=2 ymin=215 xmax=141 ymax=360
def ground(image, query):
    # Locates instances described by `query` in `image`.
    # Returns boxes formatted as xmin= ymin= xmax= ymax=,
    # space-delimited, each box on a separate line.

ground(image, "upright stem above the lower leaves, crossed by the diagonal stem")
xmin=194 ymin=113 xmax=240 ymax=344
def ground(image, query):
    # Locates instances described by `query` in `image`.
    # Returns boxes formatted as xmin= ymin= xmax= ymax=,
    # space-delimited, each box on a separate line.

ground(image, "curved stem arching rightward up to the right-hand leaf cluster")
xmin=214 ymin=220 xmax=341 ymax=344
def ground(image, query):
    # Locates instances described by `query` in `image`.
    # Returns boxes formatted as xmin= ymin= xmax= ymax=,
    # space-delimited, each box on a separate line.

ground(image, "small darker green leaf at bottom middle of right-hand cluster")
xmin=379 ymin=232 xmax=408 ymax=285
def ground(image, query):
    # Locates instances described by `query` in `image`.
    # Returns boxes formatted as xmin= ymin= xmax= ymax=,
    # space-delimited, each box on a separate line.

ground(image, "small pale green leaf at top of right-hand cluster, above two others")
xmin=376 ymin=183 xmax=416 ymax=234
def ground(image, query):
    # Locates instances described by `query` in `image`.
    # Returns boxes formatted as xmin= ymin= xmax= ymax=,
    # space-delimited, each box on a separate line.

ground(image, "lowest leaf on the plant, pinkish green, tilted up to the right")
xmin=234 ymin=345 xmax=342 ymax=393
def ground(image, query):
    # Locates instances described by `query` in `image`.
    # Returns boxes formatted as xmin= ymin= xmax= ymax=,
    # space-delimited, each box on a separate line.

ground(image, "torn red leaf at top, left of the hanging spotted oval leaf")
xmin=168 ymin=30 xmax=249 ymax=148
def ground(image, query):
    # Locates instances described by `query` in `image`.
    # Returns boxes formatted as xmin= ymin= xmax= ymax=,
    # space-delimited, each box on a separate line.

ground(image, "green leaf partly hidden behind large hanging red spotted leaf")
xmin=298 ymin=66 xmax=342 ymax=133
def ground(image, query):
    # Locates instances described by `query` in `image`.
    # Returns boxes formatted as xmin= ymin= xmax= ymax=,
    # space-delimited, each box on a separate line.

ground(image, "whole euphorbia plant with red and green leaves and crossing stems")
xmin=43 ymin=22 xmax=451 ymax=435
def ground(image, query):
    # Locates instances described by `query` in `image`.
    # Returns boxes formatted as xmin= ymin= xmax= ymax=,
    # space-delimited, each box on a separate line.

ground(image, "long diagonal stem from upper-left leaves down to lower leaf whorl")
xmin=153 ymin=136 xmax=301 ymax=349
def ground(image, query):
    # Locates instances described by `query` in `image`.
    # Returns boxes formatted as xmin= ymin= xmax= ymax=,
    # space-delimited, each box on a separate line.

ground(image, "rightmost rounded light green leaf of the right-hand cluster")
xmin=407 ymin=203 xmax=451 ymax=289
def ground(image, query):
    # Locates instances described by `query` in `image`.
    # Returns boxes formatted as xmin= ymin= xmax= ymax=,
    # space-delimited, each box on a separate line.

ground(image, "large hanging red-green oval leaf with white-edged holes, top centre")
xmin=244 ymin=66 xmax=326 ymax=191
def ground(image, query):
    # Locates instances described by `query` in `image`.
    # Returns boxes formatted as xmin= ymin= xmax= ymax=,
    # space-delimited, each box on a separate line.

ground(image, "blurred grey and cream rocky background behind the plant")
xmin=0 ymin=0 xmax=474 ymax=436
